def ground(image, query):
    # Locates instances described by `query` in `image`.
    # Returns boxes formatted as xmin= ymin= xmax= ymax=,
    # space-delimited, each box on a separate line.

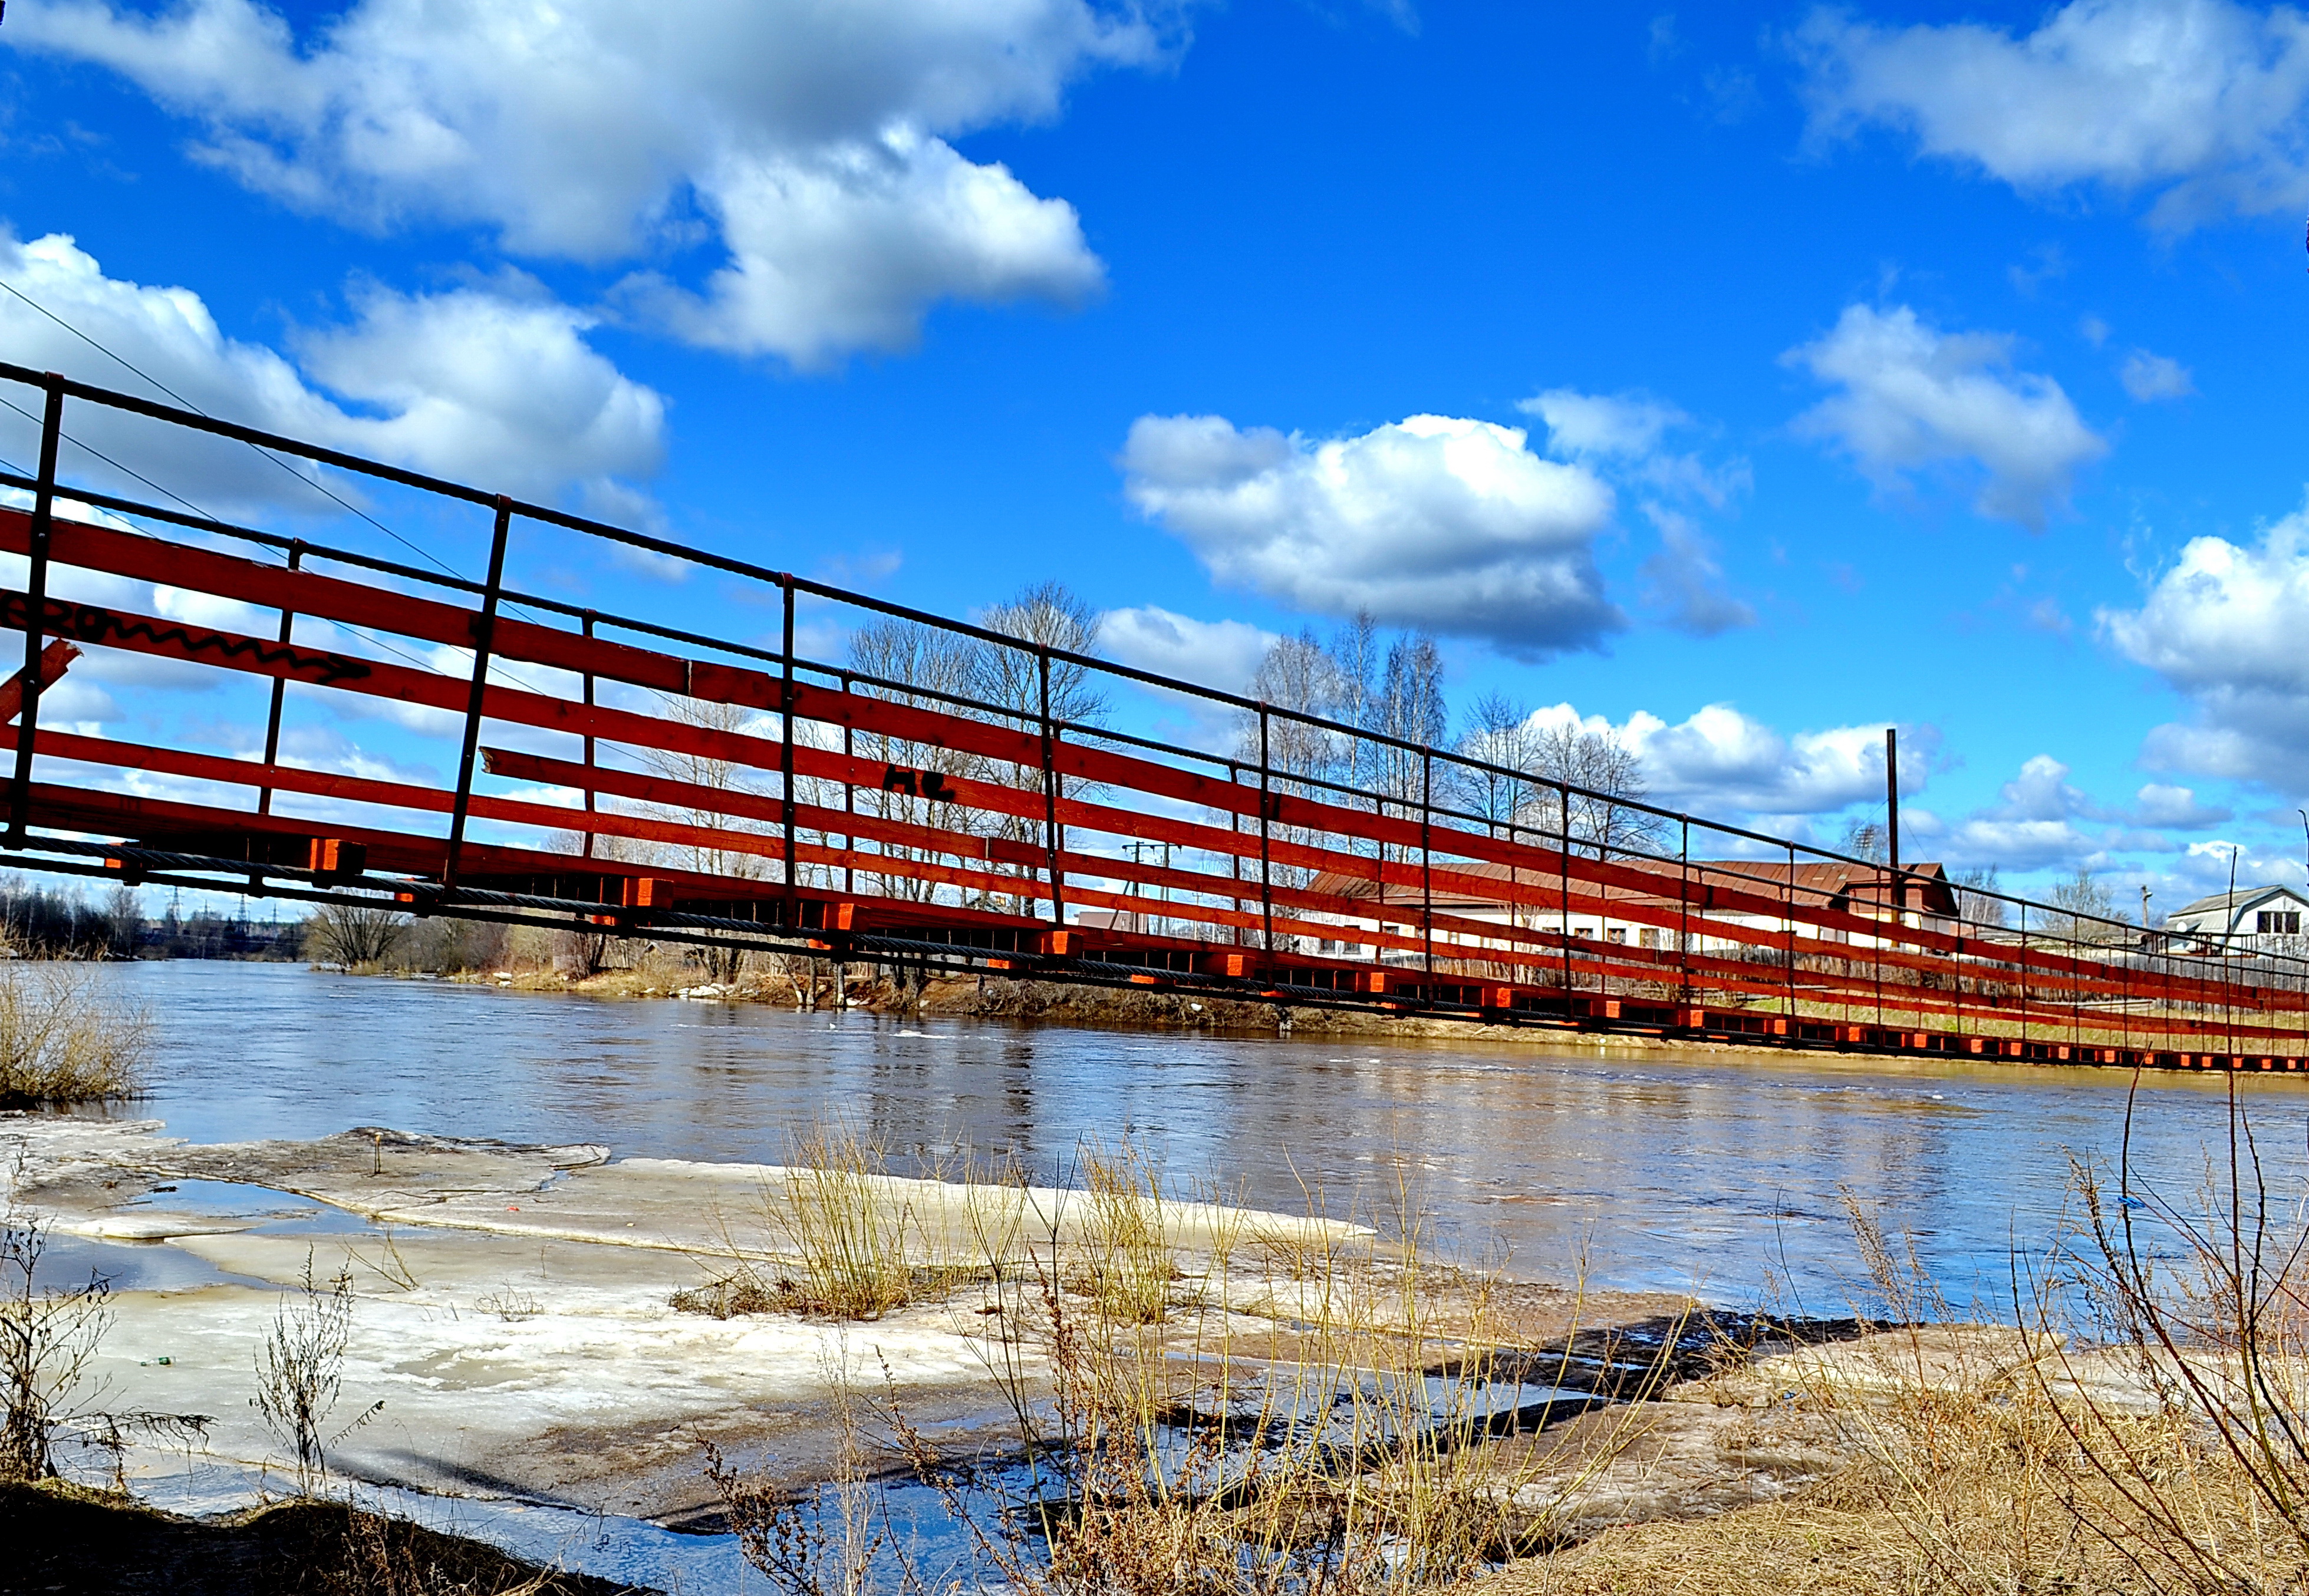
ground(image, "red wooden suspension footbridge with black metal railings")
xmin=0 ymin=365 xmax=2309 ymax=1069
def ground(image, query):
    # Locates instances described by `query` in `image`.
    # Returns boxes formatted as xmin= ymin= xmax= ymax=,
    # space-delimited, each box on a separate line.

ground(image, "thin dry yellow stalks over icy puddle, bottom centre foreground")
xmin=709 ymin=1150 xmax=1655 ymax=1596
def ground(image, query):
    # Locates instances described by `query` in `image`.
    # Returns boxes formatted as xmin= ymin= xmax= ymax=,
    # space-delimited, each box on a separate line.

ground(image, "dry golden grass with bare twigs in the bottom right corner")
xmin=1487 ymin=1118 xmax=2309 ymax=1596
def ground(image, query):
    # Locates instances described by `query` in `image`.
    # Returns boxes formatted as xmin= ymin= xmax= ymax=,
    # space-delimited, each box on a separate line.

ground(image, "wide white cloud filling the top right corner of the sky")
xmin=1794 ymin=0 xmax=2309 ymax=226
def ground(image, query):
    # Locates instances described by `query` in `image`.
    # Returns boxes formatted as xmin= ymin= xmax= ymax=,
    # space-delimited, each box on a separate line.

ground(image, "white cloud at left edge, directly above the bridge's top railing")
xmin=0 ymin=233 xmax=665 ymax=510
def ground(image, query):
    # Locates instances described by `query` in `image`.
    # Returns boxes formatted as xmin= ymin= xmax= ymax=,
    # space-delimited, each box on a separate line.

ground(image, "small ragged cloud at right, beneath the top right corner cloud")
xmin=1785 ymin=305 xmax=2108 ymax=527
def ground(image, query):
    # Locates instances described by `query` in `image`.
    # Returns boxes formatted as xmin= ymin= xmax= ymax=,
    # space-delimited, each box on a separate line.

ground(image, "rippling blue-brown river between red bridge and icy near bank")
xmin=45 ymin=961 xmax=2309 ymax=1314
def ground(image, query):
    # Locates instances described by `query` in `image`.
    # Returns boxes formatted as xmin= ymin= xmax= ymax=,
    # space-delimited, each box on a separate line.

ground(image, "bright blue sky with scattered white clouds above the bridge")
xmin=0 ymin=0 xmax=2309 ymax=908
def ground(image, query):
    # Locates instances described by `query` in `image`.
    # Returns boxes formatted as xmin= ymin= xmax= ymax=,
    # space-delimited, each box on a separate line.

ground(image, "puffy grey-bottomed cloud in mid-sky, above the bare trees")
xmin=1122 ymin=416 xmax=1626 ymax=656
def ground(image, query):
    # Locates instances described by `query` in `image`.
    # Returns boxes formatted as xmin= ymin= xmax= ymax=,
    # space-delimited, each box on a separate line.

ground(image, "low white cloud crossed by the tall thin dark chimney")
xmin=1531 ymin=704 xmax=1939 ymax=817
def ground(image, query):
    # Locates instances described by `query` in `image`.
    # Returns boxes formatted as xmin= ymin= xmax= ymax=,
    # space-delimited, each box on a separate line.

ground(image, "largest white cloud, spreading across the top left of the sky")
xmin=9 ymin=0 xmax=1166 ymax=365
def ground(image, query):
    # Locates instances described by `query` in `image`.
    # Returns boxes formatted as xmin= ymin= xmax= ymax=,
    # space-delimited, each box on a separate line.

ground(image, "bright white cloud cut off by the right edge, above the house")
xmin=2097 ymin=508 xmax=2309 ymax=799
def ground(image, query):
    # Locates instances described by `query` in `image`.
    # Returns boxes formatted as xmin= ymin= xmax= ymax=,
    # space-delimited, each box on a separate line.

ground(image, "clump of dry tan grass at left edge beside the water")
xmin=0 ymin=961 xmax=153 ymax=1109
